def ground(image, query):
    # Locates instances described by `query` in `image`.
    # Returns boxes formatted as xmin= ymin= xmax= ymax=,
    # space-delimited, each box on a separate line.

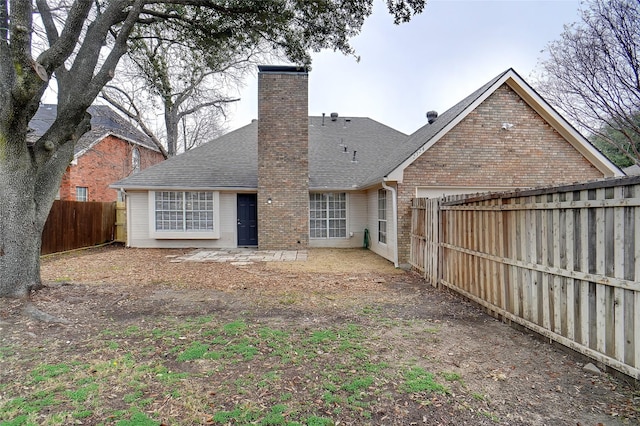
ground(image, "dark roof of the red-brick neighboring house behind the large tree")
xmin=29 ymin=104 xmax=159 ymax=155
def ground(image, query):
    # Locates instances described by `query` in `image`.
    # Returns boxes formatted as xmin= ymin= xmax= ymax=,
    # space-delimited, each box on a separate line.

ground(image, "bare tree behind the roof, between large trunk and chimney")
xmin=102 ymin=24 xmax=265 ymax=157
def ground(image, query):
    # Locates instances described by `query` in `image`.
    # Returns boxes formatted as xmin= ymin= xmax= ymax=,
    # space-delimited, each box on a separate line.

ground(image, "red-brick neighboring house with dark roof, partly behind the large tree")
xmin=29 ymin=104 xmax=164 ymax=202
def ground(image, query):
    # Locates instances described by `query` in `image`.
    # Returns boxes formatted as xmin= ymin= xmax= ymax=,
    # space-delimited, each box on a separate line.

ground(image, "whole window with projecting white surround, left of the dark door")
xmin=150 ymin=191 xmax=219 ymax=238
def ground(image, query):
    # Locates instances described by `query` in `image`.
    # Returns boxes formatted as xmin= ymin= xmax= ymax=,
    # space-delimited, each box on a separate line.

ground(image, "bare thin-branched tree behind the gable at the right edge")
xmin=539 ymin=0 xmax=640 ymax=164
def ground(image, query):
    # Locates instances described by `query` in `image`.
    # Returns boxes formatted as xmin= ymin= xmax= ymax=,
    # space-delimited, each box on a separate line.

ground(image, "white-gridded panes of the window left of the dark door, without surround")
xmin=155 ymin=191 xmax=214 ymax=232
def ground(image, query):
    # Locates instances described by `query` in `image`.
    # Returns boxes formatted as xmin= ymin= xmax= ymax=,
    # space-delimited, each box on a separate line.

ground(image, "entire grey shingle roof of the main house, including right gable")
xmin=111 ymin=68 xmax=623 ymax=191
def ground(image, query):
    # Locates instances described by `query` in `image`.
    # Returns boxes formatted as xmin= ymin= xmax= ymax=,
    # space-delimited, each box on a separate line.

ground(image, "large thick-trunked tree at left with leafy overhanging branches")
xmin=0 ymin=0 xmax=424 ymax=298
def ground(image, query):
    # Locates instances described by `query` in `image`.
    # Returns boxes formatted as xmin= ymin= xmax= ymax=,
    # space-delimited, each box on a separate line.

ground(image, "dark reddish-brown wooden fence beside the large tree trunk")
xmin=41 ymin=200 xmax=116 ymax=254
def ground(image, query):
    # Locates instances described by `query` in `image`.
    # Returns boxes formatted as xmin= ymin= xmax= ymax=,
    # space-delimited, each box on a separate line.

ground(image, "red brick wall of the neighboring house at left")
xmin=60 ymin=135 xmax=164 ymax=202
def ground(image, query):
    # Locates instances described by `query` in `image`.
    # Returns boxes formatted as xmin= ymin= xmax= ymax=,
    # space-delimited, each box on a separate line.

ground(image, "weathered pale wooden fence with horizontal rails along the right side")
xmin=410 ymin=177 xmax=640 ymax=379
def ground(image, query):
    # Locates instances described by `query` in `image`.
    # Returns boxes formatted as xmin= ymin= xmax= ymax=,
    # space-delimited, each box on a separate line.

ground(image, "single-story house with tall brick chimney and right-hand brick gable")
xmin=112 ymin=66 xmax=622 ymax=265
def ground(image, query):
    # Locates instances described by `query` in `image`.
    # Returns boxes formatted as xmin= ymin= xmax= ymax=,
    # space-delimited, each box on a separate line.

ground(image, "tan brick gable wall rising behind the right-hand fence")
xmin=398 ymin=84 xmax=603 ymax=263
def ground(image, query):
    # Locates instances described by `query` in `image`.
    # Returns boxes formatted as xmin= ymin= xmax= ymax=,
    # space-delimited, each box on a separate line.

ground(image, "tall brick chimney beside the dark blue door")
xmin=258 ymin=65 xmax=309 ymax=250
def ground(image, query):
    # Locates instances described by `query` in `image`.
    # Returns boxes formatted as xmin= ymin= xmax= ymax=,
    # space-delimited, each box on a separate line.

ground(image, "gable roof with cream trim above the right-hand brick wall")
xmin=380 ymin=68 xmax=624 ymax=182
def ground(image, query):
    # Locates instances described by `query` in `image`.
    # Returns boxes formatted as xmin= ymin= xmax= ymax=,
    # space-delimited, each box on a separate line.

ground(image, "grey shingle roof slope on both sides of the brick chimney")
xmin=113 ymin=117 xmax=407 ymax=190
